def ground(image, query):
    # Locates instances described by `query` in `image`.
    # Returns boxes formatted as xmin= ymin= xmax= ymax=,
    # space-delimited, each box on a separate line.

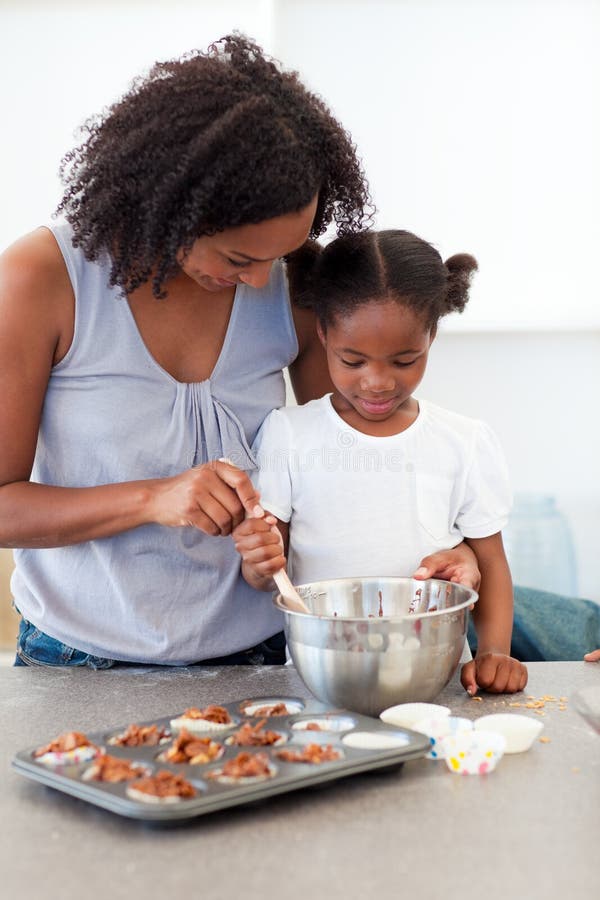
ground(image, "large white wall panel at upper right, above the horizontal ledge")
xmin=274 ymin=0 xmax=600 ymax=331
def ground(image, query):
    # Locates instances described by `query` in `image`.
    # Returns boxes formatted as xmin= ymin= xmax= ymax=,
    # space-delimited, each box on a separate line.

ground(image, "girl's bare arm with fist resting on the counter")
xmin=461 ymin=533 xmax=527 ymax=694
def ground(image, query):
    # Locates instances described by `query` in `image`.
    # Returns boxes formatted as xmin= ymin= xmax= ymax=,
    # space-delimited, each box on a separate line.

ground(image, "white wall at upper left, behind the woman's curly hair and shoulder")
xmin=0 ymin=0 xmax=272 ymax=249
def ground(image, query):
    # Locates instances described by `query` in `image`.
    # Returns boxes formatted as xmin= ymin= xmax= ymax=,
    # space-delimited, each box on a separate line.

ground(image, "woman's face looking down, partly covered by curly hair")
xmin=179 ymin=195 xmax=318 ymax=292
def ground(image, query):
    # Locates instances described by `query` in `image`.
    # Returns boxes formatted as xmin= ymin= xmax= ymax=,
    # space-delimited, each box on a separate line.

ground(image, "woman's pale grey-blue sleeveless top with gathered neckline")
xmin=12 ymin=225 xmax=298 ymax=665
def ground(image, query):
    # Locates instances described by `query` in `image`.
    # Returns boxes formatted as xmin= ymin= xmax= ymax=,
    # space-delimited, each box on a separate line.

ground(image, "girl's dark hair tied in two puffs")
xmin=288 ymin=230 xmax=477 ymax=329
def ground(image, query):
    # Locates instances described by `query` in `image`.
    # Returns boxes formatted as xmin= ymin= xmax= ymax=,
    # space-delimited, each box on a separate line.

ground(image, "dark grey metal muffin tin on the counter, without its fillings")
xmin=13 ymin=696 xmax=429 ymax=821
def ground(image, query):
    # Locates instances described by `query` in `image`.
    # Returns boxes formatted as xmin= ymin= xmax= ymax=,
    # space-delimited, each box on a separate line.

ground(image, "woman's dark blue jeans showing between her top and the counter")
xmin=14 ymin=618 xmax=285 ymax=669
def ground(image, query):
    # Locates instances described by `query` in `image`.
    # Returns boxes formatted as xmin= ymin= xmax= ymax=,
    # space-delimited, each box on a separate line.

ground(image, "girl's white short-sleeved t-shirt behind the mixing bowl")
xmin=253 ymin=394 xmax=511 ymax=584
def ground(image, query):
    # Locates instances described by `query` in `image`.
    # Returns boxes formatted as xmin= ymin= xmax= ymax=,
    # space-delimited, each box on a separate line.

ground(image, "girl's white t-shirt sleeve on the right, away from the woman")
xmin=456 ymin=422 xmax=512 ymax=538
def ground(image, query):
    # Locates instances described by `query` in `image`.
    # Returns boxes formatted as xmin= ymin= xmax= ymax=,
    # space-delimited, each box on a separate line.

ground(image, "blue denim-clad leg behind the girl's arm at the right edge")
xmin=469 ymin=587 xmax=600 ymax=662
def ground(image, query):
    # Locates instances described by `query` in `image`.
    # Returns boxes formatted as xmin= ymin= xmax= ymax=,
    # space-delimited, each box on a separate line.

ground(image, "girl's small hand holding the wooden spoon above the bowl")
xmin=232 ymin=514 xmax=287 ymax=591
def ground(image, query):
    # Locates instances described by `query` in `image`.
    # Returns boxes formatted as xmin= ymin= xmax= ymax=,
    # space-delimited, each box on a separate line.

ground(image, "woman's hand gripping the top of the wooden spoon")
xmin=148 ymin=460 xmax=264 ymax=536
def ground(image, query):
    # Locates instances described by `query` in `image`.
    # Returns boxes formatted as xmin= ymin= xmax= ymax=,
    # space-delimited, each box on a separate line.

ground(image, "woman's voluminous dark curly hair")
xmin=57 ymin=33 xmax=372 ymax=297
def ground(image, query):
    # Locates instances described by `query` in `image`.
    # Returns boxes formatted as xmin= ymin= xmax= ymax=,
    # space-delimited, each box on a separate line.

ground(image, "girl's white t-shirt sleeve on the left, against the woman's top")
xmin=251 ymin=409 xmax=292 ymax=522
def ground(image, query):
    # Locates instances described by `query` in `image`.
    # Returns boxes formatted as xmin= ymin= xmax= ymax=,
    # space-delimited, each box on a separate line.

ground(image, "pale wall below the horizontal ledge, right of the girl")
xmin=418 ymin=330 xmax=600 ymax=602
